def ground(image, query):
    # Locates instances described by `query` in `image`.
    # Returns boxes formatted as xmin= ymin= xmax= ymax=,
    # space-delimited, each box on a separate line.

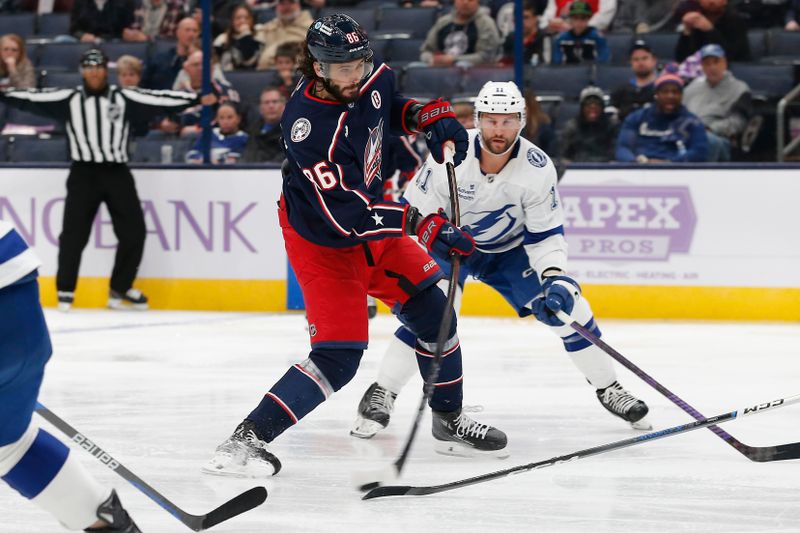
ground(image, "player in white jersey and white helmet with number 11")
xmin=350 ymin=82 xmax=650 ymax=438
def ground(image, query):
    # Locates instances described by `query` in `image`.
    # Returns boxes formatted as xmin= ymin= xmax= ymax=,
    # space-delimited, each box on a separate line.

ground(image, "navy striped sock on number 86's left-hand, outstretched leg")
xmin=247 ymin=349 xmax=363 ymax=442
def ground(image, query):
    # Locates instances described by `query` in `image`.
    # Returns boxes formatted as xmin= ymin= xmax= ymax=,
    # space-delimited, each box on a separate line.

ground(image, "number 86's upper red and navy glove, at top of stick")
xmin=417 ymin=98 xmax=469 ymax=166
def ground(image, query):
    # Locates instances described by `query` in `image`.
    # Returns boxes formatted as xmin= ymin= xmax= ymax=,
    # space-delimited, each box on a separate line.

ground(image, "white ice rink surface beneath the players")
xmin=0 ymin=310 xmax=800 ymax=533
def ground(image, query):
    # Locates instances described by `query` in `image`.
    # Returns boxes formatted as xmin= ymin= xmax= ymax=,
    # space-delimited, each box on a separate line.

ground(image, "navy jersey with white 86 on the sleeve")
xmin=281 ymin=64 xmax=414 ymax=248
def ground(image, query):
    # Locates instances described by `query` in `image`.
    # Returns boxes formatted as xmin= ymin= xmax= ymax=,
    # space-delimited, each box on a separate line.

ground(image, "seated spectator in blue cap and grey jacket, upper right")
xmin=683 ymin=44 xmax=753 ymax=162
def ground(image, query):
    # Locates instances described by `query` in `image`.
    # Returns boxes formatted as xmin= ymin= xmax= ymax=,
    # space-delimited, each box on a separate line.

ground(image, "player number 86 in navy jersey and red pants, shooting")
xmin=203 ymin=14 xmax=506 ymax=476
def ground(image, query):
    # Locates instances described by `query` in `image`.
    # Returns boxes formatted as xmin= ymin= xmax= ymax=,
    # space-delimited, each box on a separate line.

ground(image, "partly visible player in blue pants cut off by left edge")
xmin=0 ymin=220 xmax=140 ymax=533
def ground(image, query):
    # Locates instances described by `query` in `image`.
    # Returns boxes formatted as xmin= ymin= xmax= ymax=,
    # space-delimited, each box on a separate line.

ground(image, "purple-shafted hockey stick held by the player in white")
xmin=556 ymin=311 xmax=800 ymax=463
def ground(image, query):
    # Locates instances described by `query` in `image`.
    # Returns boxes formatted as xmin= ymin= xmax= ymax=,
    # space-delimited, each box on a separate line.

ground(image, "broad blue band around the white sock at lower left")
xmin=2 ymin=429 xmax=69 ymax=500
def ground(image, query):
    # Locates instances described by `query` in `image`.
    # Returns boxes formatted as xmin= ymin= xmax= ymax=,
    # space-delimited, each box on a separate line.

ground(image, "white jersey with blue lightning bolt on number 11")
xmin=404 ymin=130 xmax=567 ymax=276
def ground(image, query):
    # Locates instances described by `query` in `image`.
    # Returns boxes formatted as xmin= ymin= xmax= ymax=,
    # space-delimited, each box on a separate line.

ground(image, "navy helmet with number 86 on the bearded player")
xmin=306 ymin=13 xmax=372 ymax=64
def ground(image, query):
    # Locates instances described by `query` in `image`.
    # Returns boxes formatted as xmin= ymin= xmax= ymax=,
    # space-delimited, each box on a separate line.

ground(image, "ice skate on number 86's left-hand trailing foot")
xmin=201 ymin=420 xmax=281 ymax=477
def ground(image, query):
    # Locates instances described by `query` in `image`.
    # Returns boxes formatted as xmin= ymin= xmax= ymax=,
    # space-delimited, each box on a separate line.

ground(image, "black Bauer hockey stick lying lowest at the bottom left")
xmin=36 ymin=402 xmax=267 ymax=531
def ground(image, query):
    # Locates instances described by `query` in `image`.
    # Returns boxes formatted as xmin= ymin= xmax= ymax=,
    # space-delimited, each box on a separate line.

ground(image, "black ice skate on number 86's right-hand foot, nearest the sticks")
xmin=432 ymin=409 xmax=509 ymax=459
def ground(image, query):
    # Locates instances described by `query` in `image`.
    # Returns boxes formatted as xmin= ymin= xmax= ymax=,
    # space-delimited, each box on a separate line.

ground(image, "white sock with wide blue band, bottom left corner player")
xmin=0 ymin=426 xmax=111 ymax=530
